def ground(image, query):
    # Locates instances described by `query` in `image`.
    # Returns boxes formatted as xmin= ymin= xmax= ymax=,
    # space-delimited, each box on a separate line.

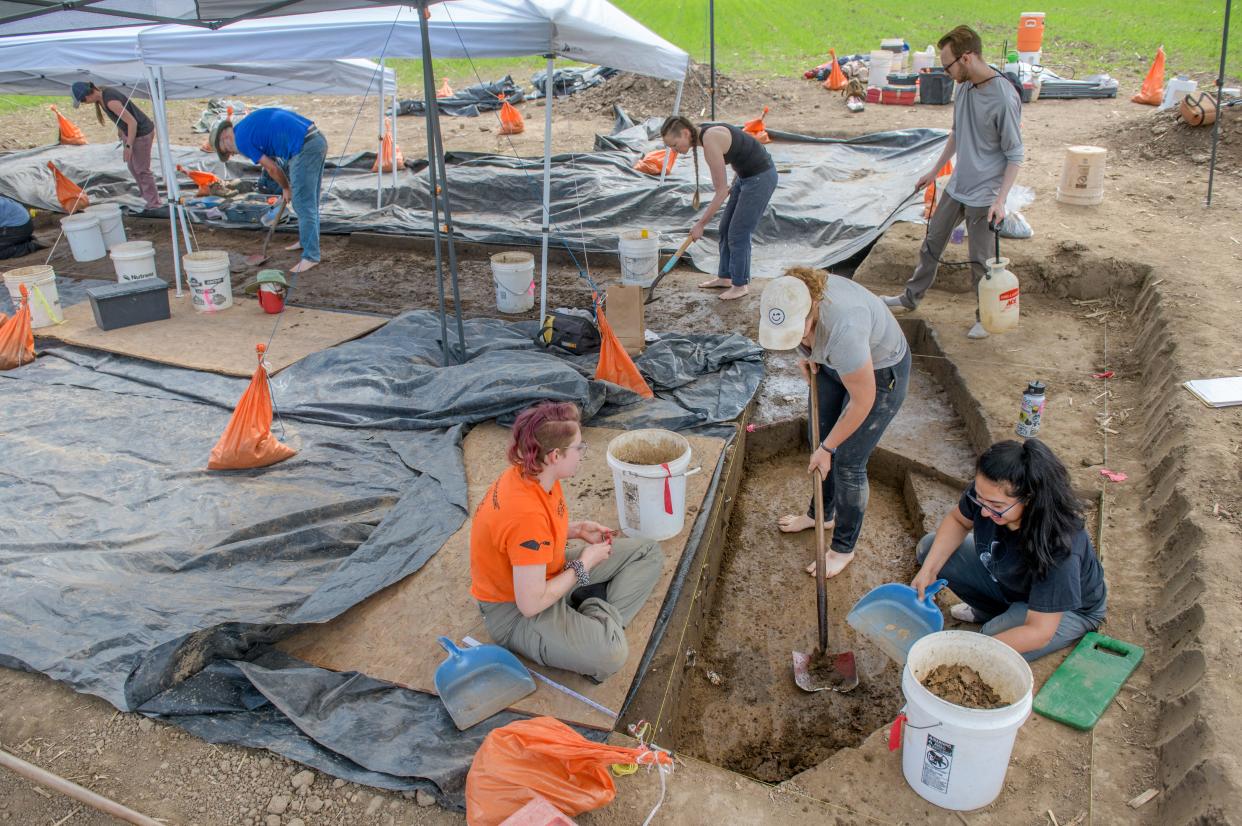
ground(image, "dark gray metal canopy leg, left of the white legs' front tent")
xmin=419 ymin=0 xmax=467 ymax=366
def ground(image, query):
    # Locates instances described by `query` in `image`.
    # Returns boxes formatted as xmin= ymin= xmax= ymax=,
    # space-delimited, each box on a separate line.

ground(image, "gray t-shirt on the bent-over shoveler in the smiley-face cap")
xmin=811 ymin=276 xmax=909 ymax=375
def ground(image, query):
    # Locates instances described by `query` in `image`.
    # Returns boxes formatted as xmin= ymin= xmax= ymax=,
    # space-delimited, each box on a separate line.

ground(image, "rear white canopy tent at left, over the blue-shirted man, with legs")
xmin=0 ymin=26 xmax=397 ymax=296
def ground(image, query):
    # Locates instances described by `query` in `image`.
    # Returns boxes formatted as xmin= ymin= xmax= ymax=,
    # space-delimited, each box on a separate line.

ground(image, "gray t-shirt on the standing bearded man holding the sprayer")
xmin=945 ymin=75 xmax=1025 ymax=206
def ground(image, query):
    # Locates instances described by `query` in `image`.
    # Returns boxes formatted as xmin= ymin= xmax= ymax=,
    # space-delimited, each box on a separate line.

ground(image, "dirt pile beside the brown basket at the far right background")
xmin=1100 ymin=106 xmax=1242 ymax=175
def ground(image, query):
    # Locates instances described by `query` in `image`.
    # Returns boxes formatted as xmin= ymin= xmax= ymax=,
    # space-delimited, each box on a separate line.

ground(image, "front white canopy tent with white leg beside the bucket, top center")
xmin=140 ymin=0 xmax=689 ymax=318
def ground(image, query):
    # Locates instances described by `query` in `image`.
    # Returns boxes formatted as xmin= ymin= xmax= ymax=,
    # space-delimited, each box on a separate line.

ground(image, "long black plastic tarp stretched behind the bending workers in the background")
xmin=0 ymin=125 xmax=946 ymax=277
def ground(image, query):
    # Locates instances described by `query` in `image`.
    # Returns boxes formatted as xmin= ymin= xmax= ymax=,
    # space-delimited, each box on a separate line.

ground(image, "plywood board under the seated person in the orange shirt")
xmin=281 ymin=425 xmax=724 ymax=729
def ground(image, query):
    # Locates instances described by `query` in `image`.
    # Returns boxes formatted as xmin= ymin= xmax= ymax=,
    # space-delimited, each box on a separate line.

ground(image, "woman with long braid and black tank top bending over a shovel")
xmin=660 ymin=114 xmax=776 ymax=301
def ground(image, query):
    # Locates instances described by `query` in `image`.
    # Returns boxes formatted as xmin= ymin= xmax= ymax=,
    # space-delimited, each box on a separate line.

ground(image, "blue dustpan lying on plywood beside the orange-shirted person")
xmin=436 ymin=637 xmax=535 ymax=730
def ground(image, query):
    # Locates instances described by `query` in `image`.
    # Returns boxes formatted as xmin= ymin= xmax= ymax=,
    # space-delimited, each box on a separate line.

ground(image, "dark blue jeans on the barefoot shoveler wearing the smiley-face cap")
xmin=806 ymin=350 xmax=910 ymax=554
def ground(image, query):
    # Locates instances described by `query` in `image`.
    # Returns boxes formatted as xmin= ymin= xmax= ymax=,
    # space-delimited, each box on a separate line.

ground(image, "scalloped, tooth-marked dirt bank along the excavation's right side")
xmin=1135 ymin=277 xmax=1242 ymax=826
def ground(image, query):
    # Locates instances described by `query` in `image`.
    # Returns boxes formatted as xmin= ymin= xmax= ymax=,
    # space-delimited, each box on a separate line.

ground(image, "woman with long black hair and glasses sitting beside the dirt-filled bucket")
xmin=910 ymin=438 xmax=1108 ymax=662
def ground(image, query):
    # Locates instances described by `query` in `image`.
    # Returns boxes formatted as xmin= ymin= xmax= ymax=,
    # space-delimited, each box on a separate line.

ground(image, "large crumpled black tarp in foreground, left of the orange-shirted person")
xmin=0 ymin=296 xmax=763 ymax=805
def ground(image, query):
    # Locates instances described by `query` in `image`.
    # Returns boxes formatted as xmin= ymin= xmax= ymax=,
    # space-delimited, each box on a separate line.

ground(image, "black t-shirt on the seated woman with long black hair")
xmin=958 ymin=486 xmax=1108 ymax=614
